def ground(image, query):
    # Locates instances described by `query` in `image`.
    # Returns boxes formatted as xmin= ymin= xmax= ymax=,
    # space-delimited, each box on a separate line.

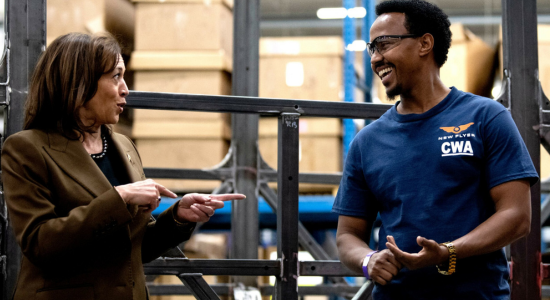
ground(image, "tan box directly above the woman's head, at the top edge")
xmin=46 ymin=0 xmax=135 ymax=49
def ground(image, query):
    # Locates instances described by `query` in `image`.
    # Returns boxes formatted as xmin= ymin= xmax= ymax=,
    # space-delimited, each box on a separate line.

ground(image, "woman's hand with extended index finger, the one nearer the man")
xmin=176 ymin=193 xmax=246 ymax=223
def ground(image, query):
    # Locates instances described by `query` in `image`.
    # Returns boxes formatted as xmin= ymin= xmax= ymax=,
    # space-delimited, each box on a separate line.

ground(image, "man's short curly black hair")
xmin=376 ymin=0 xmax=452 ymax=67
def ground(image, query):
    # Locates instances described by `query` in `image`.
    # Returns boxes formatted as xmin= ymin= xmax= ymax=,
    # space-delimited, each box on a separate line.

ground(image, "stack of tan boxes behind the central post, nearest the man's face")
xmin=259 ymin=37 xmax=344 ymax=193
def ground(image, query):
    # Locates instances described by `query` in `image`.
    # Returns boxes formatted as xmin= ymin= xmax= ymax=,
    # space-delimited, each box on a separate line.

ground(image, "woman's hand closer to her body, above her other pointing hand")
xmin=115 ymin=179 xmax=177 ymax=212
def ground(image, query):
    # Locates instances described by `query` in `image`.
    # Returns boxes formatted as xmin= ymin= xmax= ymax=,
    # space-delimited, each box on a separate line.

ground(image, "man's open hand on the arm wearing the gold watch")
xmin=386 ymin=235 xmax=449 ymax=270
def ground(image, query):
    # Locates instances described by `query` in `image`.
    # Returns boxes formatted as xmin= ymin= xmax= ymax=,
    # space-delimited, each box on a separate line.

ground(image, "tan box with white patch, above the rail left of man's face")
xmin=259 ymin=36 xmax=344 ymax=101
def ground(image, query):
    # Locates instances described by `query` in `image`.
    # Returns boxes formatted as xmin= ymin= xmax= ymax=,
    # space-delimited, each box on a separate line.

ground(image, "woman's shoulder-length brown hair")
xmin=24 ymin=33 xmax=121 ymax=138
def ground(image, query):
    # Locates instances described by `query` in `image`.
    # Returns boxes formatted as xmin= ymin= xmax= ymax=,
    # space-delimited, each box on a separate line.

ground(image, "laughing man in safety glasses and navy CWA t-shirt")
xmin=333 ymin=0 xmax=538 ymax=300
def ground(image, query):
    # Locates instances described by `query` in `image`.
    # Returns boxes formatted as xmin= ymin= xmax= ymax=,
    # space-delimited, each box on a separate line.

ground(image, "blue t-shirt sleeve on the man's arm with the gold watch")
xmin=483 ymin=110 xmax=538 ymax=189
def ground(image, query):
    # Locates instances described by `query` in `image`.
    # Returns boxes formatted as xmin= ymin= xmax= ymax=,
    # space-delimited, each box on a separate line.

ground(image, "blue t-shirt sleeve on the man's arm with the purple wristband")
xmin=332 ymin=138 xmax=378 ymax=218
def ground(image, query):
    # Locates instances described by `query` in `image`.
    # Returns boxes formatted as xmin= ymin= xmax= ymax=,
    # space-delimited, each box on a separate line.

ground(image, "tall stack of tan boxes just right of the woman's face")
xmin=130 ymin=0 xmax=233 ymax=192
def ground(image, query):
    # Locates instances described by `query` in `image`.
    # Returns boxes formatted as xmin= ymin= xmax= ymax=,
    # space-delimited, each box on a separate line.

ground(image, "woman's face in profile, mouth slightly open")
xmin=80 ymin=54 xmax=128 ymax=129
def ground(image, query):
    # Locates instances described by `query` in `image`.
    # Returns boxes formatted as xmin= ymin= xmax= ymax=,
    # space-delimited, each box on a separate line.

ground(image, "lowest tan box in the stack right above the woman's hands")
xmin=136 ymin=138 xmax=229 ymax=193
